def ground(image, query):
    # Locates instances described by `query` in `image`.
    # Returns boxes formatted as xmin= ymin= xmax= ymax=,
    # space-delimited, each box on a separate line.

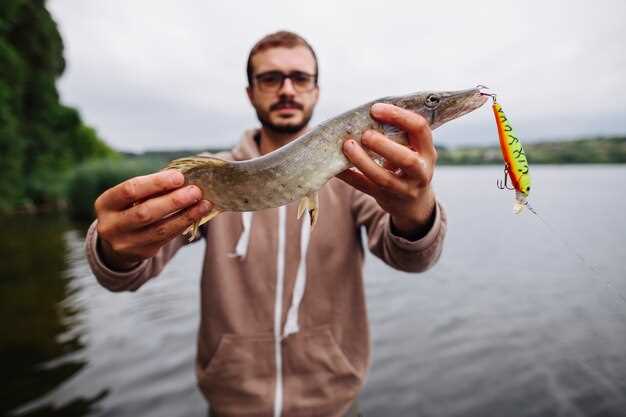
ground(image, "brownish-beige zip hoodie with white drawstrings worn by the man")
xmin=86 ymin=131 xmax=446 ymax=417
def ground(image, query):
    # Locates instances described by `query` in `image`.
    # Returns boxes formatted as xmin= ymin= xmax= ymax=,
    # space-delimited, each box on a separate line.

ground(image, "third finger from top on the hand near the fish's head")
xmin=343 ymin=139 xmax=416 ymax=195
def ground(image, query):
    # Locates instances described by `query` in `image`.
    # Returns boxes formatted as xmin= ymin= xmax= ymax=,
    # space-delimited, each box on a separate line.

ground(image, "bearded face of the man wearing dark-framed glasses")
xmin=247 ymin=46 xmax=319 ymax=133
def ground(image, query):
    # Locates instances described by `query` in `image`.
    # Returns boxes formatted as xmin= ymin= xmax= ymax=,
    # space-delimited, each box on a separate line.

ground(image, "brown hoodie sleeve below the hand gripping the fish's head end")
xmin=352 ymin=190 xmax=447 ymax=272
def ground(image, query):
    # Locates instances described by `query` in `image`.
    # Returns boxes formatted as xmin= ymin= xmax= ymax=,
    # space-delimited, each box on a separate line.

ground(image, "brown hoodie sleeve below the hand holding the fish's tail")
xmin=85 ymin=220 xmax=186 ymax=292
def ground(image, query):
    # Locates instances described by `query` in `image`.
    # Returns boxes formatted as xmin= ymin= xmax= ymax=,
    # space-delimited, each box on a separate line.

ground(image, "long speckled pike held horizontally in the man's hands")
xmin=163 ymin=86 xmax=487 ymax=240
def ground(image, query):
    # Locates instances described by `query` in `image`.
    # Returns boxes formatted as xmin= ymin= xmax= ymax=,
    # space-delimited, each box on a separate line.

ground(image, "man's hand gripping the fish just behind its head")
xmin=337 ymin=103 xmax=437 ymax=240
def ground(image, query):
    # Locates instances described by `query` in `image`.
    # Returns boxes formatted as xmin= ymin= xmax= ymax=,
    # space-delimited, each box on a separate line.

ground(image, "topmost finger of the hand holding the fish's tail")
xmin=95 ymin=170 xmax=185 ymax=212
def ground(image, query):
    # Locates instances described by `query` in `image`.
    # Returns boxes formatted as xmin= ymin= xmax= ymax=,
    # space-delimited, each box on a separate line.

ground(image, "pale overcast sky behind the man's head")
xmin=47 ymin=0 xmax=626 ymax=151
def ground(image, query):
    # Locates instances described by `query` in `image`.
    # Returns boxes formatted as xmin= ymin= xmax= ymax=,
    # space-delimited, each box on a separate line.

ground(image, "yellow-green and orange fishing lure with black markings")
xmin=492 ymin=101 xmax=530 ymax=213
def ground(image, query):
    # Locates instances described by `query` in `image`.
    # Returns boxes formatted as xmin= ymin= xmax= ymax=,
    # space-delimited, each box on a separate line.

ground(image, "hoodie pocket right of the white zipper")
xmin=283 ymin=326 xmax=363 ymax=416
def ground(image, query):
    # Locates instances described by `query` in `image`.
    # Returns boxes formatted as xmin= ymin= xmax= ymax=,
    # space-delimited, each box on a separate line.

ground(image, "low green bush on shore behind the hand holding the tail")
xmin=67 ymin=158 xmax=166 ymax=221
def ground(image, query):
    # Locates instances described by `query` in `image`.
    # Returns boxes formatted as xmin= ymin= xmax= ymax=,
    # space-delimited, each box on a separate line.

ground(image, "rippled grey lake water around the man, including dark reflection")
xmin=0 ymin=166 xmax=626 ymax=417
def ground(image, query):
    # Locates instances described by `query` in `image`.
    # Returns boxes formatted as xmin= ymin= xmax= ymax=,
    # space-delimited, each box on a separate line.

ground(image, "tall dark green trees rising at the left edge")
xmin=0 ymin=0 xmax=116 ymax=213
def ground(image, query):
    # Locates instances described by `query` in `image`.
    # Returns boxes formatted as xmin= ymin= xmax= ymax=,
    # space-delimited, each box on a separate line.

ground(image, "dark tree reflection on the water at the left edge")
xmin=0 ymin=216 xmax=107 ymax=416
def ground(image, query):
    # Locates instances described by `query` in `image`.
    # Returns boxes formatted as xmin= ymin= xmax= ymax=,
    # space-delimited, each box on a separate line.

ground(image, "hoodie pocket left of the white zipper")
xmin=198 ymin=333 xmax=276 ymax=416
